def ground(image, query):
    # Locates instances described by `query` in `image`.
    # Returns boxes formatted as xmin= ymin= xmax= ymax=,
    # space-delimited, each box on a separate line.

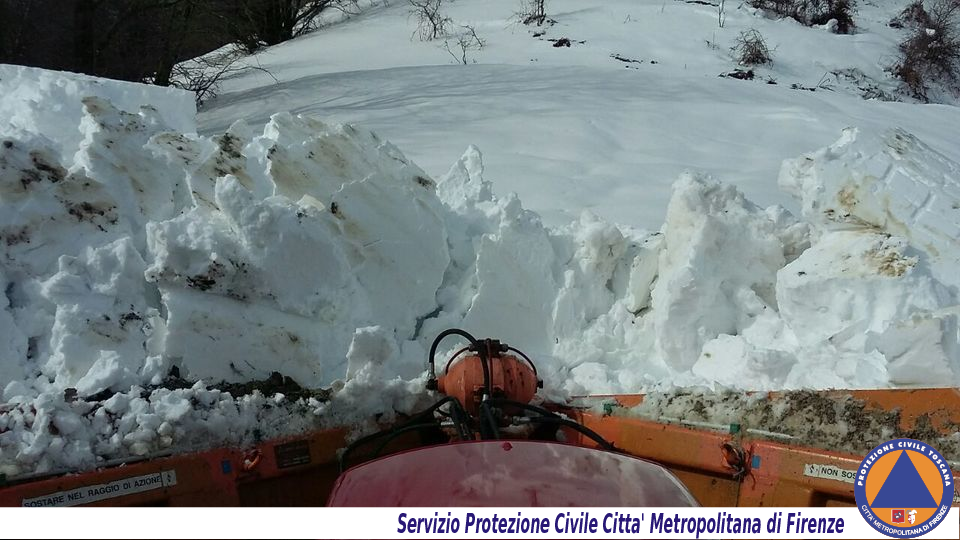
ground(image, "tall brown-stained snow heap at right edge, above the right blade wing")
xmin=777 ymin=129 xmax=960 ymax=386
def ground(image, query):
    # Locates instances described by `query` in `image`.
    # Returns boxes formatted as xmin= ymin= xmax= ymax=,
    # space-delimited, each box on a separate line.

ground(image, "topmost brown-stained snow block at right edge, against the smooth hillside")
xmin=779 ymin=129 xmax=960 ymax=292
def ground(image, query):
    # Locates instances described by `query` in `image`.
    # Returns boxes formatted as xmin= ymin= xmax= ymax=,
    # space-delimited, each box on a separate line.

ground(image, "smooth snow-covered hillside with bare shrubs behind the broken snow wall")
xmin=198 ymin=0 xmax=960 ymax=230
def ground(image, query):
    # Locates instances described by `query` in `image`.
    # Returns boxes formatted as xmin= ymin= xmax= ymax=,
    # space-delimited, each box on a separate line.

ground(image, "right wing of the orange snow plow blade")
xmin=568 ymin=388 xmax=960 ymax=506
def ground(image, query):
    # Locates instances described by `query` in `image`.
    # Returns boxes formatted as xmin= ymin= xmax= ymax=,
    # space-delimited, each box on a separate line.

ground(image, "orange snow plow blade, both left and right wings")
xmin=0 ymin=389 xmax=960 ymax=506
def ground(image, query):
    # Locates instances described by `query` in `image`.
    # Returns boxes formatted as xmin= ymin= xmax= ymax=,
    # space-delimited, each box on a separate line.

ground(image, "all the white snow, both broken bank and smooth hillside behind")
xmin=0 ymin=0 xmax=960 ymax=474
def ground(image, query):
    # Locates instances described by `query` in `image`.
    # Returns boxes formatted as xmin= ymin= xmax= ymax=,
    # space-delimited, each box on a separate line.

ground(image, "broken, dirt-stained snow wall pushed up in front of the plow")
xmin=0 ymin=67 xmax=960 ymax=473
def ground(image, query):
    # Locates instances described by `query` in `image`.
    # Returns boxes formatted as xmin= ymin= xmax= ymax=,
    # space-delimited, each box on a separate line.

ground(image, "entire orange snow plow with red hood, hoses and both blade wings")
xmin=0 ymin=329 xmax=960 ymax=506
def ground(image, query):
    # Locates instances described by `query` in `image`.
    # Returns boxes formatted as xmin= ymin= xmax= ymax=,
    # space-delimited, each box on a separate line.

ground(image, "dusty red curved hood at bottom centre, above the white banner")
xmin=328 ymin=440 xmax=699 ymax=507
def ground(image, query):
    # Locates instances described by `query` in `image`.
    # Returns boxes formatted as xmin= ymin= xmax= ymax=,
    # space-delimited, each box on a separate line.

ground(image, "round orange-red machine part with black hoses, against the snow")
xmin=437 ymin=354 xmax=538 ymax=415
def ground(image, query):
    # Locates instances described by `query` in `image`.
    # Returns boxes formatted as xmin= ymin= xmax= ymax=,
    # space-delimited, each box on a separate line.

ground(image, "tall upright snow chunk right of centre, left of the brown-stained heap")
xmin=651 ymin=175 xmax=784 ymax=370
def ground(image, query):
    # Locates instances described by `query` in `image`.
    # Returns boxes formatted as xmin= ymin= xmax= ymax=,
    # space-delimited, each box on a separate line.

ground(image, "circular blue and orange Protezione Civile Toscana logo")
xmin=853 ymin=439 xmax=954 ymax=538
